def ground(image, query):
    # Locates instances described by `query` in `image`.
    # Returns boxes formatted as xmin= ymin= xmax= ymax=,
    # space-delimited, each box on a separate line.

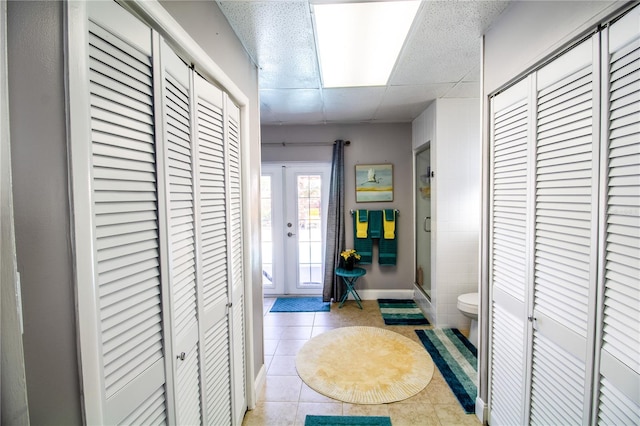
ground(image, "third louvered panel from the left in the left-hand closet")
xmin=194 ymin=75 xmax=232 ymax=425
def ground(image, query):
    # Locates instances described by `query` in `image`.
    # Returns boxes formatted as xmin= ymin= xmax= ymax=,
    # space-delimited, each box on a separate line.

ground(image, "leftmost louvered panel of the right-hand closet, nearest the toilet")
xmin=490 ymin=79 xmax=531 ymax=425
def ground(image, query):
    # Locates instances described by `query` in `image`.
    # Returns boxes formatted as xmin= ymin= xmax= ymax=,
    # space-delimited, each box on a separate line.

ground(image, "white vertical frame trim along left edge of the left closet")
xmin=65 ymin=2 xmax=104 ymax=424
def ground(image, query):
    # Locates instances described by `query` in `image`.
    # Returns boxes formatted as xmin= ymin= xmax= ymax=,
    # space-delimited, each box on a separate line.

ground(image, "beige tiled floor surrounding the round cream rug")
xmin=242 ymin=299 xmax=480 ymax=426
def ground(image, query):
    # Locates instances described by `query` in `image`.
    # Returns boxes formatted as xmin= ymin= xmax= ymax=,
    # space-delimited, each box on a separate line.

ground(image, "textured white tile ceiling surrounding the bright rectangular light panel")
xmin=218 ymin=0 xmax=509 ymax=124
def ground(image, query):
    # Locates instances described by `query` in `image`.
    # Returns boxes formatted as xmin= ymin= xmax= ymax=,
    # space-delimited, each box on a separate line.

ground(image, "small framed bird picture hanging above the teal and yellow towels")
xmin=356 ymin=164 xmax=393 ymax=203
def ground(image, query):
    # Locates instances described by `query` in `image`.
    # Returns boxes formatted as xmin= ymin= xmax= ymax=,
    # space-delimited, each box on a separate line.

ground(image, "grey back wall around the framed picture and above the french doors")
xmin=262 ymin=123 xmax=414 ymax=297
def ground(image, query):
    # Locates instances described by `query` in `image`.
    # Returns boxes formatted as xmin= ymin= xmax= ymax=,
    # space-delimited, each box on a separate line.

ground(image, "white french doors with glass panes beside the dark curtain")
xmin=261 ymin=163 xmax=331 ymax=295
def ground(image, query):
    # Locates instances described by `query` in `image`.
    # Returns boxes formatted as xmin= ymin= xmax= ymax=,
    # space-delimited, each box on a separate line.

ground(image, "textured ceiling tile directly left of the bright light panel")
xmin=218 ymin=1 xmax=320 ymax=89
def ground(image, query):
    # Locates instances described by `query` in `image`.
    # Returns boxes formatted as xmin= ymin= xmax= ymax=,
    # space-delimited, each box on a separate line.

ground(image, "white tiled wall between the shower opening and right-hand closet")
xmin=413 ymin=99 xmax=481 ymax=329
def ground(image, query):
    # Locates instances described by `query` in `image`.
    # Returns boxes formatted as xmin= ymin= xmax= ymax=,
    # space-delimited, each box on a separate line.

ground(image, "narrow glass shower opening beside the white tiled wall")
xmin=415 ymin=143 xmax=432 ymax=301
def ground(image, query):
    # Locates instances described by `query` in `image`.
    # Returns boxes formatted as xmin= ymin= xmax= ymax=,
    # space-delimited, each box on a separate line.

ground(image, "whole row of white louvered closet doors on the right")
xmin=489 ymin=6 xmax=640 ymax=425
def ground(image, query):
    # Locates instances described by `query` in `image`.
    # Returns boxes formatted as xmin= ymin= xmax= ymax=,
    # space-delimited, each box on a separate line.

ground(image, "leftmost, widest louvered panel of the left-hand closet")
xmin=87 ymin=4 xmax=166 ymax=424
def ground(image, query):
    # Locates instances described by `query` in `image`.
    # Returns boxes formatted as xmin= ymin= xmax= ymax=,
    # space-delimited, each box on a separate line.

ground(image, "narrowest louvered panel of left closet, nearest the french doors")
xmin=226 ymin=98 xmax=247 ymax=424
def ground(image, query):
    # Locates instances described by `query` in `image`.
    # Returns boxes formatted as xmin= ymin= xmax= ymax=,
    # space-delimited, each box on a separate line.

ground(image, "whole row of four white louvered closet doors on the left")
xmin=68 ymin=1 xmax=247 ymax=425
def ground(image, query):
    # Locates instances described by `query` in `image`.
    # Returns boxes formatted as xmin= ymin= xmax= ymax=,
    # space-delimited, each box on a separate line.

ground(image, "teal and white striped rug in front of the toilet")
xmin=416 ymin=328 xmax=478 ymax=414
